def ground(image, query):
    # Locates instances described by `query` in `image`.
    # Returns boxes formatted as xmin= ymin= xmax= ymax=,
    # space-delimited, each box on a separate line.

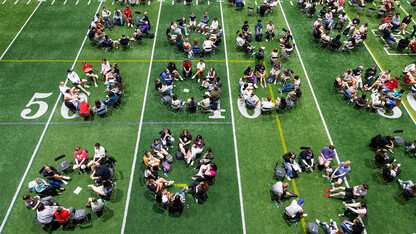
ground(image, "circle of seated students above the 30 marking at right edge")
xmin=334 ymin=63 xmax=416 ymax=114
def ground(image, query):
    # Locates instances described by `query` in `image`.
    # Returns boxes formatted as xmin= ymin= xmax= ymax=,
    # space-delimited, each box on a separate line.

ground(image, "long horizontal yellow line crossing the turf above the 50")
xmin=0 ymin=59 xmax=252 ymax=63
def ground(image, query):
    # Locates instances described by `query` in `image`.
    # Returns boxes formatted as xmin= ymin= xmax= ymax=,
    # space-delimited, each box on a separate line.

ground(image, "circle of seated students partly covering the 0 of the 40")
xmin=238 ymin=61 xmax=302 ymax=112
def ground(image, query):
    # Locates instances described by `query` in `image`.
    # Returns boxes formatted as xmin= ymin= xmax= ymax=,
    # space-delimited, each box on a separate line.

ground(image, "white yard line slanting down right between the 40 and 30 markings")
xmin=279 ymin=3 xmax=367 ymax=234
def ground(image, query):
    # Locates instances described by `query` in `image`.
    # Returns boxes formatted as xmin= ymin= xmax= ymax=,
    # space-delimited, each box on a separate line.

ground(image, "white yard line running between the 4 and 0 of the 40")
xmin=220 ymin=2 xmax=246 ymax=234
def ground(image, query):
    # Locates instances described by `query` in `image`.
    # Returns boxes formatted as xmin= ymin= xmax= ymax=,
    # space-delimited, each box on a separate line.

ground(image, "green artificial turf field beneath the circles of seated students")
xmin=0 ymin=0 xmax=416 ymax=233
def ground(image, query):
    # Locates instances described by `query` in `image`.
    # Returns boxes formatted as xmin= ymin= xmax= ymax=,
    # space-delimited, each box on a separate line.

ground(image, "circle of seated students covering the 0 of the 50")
xmin=59 ymin=59 xmax=124 ymax=120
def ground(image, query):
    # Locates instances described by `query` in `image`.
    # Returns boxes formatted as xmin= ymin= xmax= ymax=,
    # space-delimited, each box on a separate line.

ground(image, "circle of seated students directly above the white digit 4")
xmin=154 ymin=59 xmax=222 ymax=113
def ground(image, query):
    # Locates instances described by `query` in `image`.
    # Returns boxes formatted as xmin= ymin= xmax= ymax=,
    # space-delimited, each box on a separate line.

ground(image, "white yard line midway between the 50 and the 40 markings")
xmin=121 ymin=1 xmax=163 ymax=234
